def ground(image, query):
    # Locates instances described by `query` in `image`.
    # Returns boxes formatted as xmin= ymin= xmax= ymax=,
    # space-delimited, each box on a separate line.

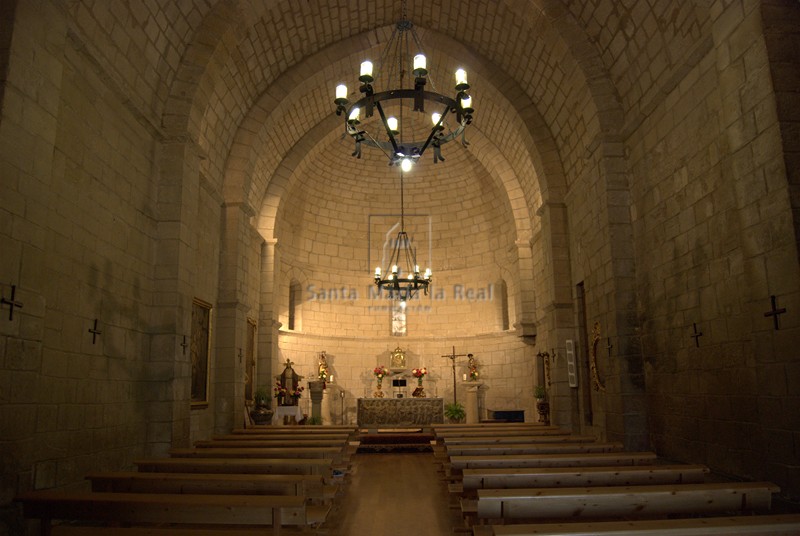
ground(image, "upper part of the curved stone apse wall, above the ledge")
xmin=275 ymin=144 xmax=518 ymax=339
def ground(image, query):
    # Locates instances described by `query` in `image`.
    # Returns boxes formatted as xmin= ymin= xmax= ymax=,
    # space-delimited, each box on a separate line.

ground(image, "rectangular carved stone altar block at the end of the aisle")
xmin=357 ymin=398 xmax=444 ymax=428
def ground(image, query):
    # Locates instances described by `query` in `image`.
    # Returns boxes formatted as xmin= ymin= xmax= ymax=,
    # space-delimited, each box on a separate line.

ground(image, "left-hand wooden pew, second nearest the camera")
xmin=86 ymin=471 xmax=336 ymax=502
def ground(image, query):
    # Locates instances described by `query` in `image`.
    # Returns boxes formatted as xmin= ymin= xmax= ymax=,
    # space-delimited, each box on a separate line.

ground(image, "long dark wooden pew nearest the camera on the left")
xmin=15 ymin=490 xmax=327 ymax=536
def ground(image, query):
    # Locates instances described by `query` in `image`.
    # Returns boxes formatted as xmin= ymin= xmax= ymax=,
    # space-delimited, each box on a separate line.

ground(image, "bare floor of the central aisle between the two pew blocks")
xmin=324 ymin=452 xmax=459 ymax=536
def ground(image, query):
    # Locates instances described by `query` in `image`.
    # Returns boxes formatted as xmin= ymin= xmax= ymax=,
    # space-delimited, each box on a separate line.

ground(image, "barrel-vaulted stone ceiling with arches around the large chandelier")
xmin=65 ymin=0 xmax=710 ymax=245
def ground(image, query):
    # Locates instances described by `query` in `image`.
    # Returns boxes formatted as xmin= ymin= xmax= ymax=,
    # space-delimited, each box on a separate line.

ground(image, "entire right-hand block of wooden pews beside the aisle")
xmin=434 ymin=424 xmax=800 ymax=536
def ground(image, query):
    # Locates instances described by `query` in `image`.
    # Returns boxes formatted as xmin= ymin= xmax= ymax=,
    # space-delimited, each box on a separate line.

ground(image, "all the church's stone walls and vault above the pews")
xmin=0 ymin=0 xmax=800 ymax=535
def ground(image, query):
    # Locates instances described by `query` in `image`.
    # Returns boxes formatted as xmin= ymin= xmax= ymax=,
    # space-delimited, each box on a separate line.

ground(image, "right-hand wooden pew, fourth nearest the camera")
xmin=450 ymin=452 xmax=658 ymax=470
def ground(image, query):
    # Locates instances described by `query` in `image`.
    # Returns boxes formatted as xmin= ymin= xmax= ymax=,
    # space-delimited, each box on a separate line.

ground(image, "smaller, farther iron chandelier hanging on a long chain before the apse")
xmin=375 ymin=167 xmax=432 ymax=302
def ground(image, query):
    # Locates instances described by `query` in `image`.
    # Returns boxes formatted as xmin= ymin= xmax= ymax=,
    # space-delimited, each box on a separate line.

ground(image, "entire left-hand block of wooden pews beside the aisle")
xmin=16 ymin=426 xmax=356 ymax=536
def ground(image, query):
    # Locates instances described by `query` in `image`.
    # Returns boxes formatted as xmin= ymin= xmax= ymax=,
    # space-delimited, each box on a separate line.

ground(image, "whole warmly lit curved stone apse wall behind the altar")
xmin=273 ymin=142 xmax=535 ymax=416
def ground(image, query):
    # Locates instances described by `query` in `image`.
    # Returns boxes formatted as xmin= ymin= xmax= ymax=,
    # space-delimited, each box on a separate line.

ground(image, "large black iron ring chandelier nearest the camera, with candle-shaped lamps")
xmin=334 ymin=2 xmax=474 ymax=171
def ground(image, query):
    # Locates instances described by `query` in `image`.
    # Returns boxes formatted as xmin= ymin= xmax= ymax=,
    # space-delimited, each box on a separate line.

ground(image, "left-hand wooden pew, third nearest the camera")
xmin=133 ymin=458 xmax=333 ymax=482
